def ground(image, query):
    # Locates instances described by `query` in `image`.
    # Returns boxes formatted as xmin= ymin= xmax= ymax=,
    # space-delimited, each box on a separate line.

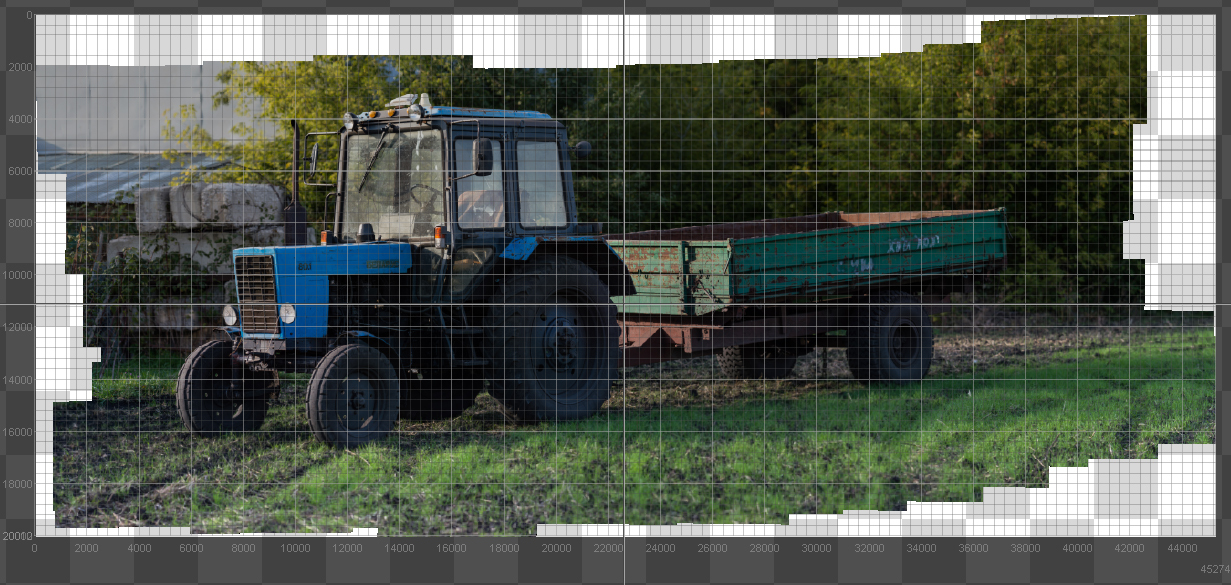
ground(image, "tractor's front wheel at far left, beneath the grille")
xmin=175 ymin=340 xmax=278 ymax=436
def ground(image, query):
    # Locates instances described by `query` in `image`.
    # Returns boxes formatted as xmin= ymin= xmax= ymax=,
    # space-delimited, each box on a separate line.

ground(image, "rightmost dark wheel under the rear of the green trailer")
xmin=847 ymin=291 xmax=932 ymax=384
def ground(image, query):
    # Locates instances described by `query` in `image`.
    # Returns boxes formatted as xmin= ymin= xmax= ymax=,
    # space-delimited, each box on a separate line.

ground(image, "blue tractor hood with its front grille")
xmin=233 ymin=241 xmax=415 ymax=339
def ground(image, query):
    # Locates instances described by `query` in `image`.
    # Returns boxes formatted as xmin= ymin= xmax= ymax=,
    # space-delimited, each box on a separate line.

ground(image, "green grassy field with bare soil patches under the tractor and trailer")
xmin=54 ymin=326 xmax=1214 ymax=535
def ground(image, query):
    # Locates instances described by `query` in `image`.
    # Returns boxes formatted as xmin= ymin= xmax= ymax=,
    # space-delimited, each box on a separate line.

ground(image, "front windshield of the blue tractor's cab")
xmin=341 ymin=129 xmax=444 ymax=240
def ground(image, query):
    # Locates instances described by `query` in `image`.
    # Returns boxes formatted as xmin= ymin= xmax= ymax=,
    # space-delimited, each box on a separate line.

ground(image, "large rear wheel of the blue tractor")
xmin=483 ymin=256 xmax=620 ymax=421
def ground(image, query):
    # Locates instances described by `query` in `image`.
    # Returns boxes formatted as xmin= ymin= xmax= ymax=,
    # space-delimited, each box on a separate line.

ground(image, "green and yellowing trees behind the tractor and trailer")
xmin=165 ymin=16 xmax=1146 ymax=309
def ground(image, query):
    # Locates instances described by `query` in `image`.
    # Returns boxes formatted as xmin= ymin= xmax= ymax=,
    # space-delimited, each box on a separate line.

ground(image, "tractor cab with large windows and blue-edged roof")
xmin=336 ymin=95 xmax=588 ymax=243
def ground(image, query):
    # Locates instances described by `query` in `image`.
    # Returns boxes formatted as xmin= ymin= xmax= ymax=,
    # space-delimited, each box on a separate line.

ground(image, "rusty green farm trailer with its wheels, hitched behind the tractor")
xmin=607 ymin=208 xmax=1007 ymax=383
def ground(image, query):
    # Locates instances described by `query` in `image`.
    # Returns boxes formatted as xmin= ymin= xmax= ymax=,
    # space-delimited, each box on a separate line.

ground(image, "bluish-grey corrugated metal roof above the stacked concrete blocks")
xmin=38 ymin=144 xmax=228 ymax=203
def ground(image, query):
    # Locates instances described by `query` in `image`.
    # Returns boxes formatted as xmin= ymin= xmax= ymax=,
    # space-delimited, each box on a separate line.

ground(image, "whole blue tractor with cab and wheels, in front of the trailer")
xmin=176 ymin=95 xmax=634 ymax=446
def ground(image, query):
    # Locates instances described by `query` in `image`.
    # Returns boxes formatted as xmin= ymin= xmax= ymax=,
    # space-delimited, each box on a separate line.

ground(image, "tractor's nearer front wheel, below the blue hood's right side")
xmin=308 ymin=344 xmax=400 ymax=447
